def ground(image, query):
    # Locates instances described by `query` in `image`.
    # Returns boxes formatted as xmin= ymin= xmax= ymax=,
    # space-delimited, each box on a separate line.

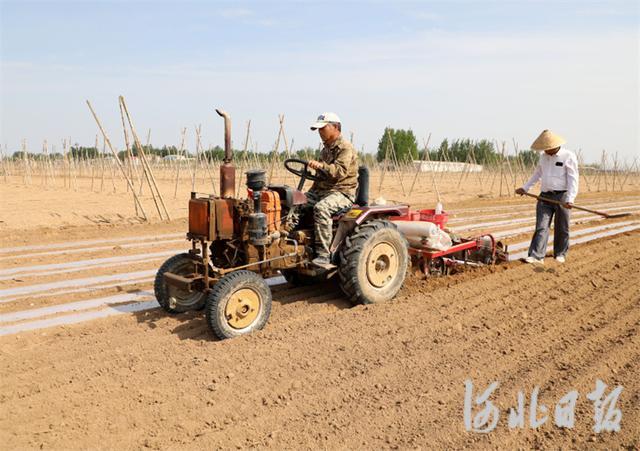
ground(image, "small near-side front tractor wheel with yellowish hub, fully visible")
xmin=206 ymin=270 xmax=271 ymax=340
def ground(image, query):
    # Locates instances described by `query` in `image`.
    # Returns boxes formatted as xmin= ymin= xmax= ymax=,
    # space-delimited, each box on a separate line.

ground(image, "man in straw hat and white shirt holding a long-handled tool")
xmin=516 ymin=130 xmax=579 ymax=264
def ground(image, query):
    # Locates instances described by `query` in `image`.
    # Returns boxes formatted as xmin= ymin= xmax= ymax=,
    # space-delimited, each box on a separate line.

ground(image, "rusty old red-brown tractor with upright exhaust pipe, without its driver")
xmin=154 ymin=110 xmax=411 ymax=339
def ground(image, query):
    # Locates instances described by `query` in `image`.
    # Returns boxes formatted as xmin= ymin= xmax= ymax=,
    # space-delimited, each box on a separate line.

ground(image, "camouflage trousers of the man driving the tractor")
xmin=286 ymin=191 xmax=353 ymax=257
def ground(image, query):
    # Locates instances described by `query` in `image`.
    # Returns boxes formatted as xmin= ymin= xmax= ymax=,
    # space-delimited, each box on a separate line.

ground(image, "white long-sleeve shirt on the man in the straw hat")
xmin=522 ymin=147 xmax=580 ymax=203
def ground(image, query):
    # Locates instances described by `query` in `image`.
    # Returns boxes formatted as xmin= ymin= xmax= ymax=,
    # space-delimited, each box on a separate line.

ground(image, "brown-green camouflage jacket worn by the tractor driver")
xmin=311 ymin=135 xmax=358 ymax=197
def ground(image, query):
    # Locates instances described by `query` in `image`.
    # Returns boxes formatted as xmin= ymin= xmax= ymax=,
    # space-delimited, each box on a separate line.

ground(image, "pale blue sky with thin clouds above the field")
xmin=0 ymin=0 xmax=640 ymax=161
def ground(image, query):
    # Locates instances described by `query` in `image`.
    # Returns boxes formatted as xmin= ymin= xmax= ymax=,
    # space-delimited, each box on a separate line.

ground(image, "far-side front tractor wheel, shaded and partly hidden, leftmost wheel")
xmin=153 ymin=254 xmax=207 ymax=314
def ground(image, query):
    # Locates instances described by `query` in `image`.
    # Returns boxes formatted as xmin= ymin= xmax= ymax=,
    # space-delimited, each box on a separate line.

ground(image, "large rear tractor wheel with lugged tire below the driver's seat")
xmin=338 ymin=219 xmax=409 ymax=304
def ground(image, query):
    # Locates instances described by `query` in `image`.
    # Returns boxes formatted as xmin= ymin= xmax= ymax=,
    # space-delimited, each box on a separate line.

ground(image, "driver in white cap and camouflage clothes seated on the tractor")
xmin=294 ymin=113 xmax=358 ymax=269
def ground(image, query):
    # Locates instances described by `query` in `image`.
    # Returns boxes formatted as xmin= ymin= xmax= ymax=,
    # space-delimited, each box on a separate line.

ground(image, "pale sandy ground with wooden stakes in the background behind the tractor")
xmin=0 ymin=170 xmax=640 ymax=232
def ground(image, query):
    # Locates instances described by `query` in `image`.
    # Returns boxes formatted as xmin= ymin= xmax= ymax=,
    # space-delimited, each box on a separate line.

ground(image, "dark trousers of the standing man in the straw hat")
xmin=529 ymin=191 xmax=571 ymax=258
